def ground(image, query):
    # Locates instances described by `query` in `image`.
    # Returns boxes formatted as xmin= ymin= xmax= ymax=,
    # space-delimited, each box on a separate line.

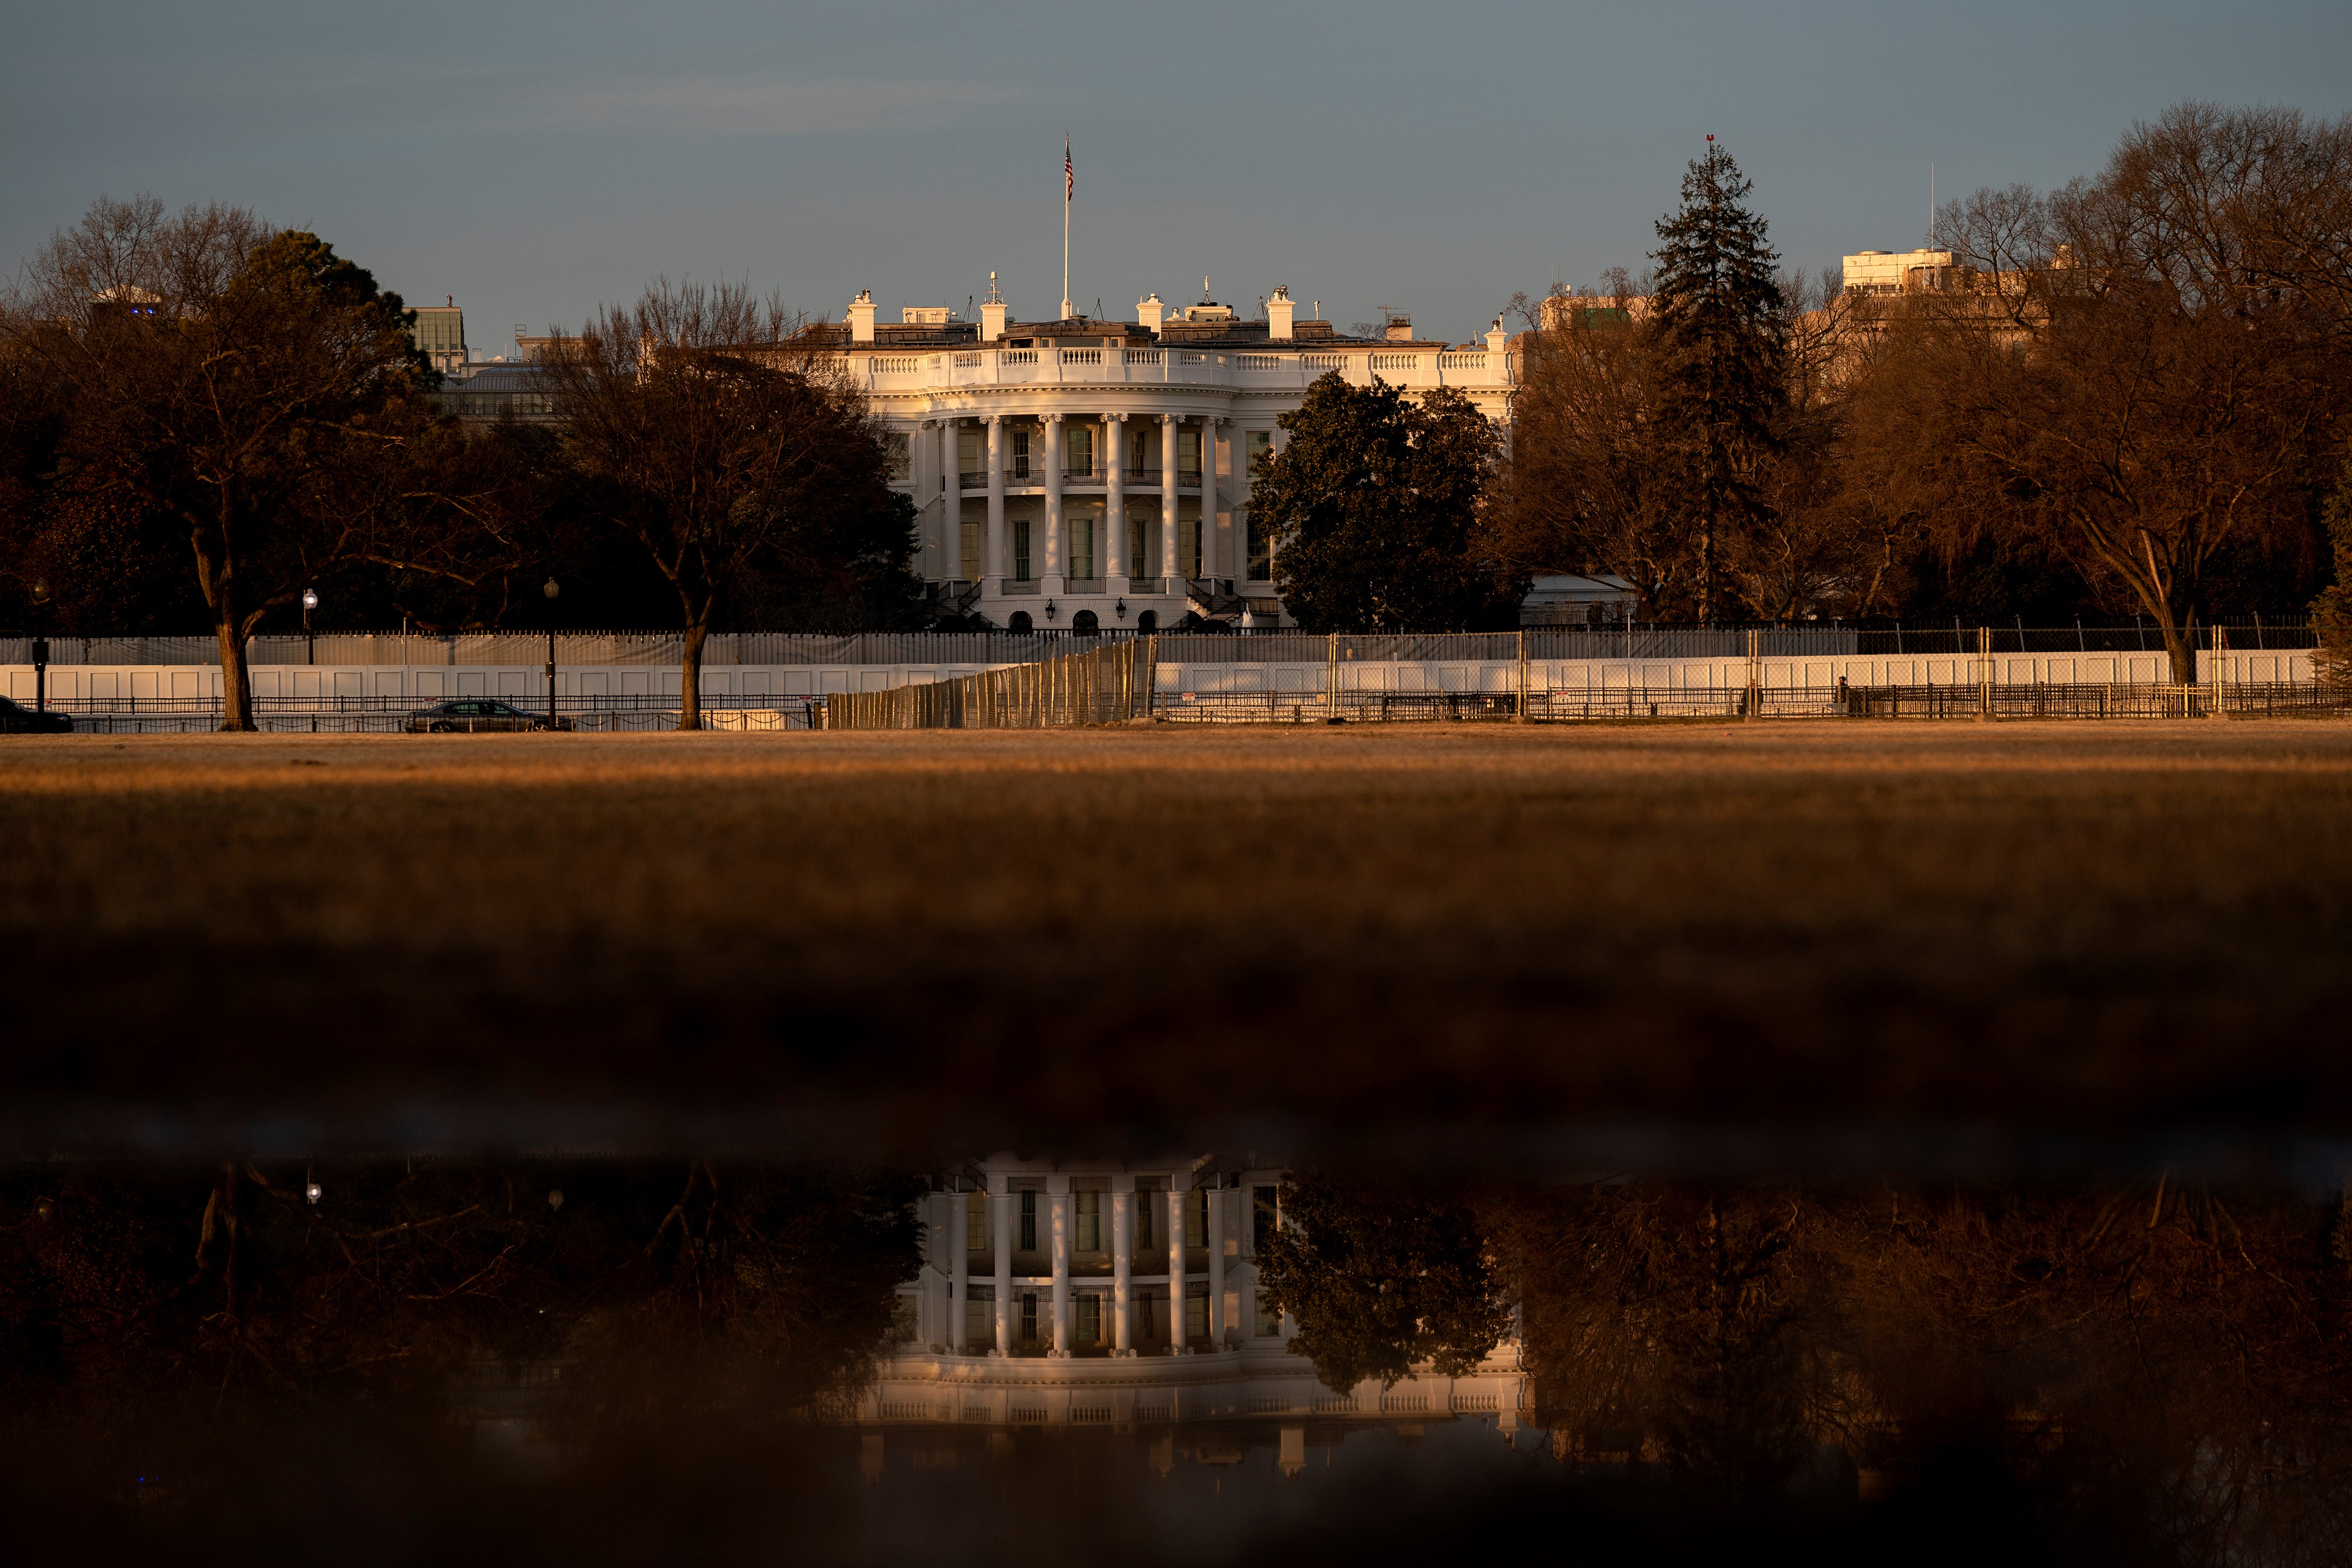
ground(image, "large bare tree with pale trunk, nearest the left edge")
xmin=0 ymin=195 xmax=487 ymax=729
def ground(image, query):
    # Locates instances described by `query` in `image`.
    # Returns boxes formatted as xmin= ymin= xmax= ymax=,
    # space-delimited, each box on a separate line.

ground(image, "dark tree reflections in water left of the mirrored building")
xmin=0 ymin=1161 xmax=915 ymax=1439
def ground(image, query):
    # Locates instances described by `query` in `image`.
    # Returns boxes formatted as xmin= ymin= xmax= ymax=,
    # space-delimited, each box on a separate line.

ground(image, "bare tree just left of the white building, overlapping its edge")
xmin=546 ymin=280 xmax=913 ymax=729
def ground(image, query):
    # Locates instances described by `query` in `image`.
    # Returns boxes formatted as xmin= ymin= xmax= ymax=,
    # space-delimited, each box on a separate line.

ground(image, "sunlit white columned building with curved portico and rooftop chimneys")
xmin=837 ymin=287 xmax=1512 ymax=630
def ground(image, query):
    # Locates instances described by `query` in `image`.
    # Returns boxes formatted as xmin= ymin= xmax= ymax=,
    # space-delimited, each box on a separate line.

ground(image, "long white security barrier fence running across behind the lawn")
xmin=0 ymin=628 xmax=2343 ymax=729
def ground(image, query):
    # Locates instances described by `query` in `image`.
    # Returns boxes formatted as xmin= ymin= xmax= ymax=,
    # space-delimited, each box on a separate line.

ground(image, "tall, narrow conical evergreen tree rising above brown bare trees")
xmin=1651 ymin=141 xmax=1785 ymax=621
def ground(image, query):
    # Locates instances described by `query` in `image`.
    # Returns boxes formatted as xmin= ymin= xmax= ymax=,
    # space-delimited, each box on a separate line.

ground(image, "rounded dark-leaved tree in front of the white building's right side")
xmin=1251 ymin=374 xmax=1526 ymax=633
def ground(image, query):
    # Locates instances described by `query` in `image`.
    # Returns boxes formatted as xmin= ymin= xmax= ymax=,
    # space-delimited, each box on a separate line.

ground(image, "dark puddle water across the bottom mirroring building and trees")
xmin=0 ymin=1154 xmax=2352 ymax=1563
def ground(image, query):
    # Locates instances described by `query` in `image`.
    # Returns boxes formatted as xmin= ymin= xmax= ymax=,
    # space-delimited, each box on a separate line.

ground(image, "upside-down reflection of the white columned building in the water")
xmin=861 ymin=1156 xmax=1524 ymax=1429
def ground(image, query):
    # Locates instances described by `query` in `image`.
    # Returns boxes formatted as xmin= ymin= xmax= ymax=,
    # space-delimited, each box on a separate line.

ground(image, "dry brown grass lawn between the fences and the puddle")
xmin=0 ymin=722 xmax=2352 ymax=1166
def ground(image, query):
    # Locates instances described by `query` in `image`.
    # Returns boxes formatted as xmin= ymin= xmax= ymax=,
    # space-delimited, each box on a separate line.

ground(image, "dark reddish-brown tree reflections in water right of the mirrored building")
xmin=1498 ymin=1185 xmax=2352 ymax=1563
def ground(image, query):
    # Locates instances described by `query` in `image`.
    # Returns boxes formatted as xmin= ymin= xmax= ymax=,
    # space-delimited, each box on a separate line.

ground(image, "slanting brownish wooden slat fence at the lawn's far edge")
xmin=826 ymin=637 xmax=1160 ymax=729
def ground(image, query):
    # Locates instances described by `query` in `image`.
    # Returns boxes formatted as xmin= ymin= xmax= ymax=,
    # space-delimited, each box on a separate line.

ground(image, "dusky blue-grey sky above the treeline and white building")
xmin=0 ymin=0 xmax=2352 ymax=355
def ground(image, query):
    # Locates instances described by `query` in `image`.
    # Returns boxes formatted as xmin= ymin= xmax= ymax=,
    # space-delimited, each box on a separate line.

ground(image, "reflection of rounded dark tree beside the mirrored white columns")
xmin=1258 ymin=1175 xmax=1510 ymax=1392
